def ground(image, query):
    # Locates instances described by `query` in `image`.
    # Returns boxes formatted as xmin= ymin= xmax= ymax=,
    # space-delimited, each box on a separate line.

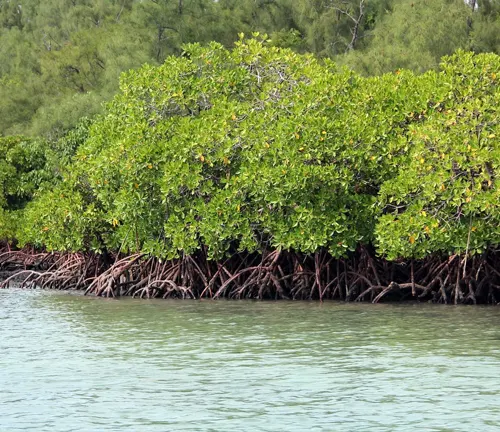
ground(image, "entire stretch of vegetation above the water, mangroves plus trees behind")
xmin=0 ymin=0 xmax=500 ymax=303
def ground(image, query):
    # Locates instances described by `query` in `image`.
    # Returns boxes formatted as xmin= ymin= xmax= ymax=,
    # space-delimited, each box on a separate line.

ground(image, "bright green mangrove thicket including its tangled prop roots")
xmin=0 ymin=36 xmax=500 ymax=302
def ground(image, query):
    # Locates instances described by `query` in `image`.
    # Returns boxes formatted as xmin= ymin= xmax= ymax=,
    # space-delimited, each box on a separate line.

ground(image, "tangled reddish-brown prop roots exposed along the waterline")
xmin=0 ymin=246 xmax=500 ymax=304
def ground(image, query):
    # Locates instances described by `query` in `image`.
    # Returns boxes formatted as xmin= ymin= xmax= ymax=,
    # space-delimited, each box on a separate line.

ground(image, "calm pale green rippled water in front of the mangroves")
xmin=0 ymin=290 xmax=500 ymax=432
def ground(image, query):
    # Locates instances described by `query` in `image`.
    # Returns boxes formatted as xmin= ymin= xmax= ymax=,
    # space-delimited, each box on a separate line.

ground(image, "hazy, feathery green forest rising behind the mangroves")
xmin=0 ymin=0 xmax=500 ymax=139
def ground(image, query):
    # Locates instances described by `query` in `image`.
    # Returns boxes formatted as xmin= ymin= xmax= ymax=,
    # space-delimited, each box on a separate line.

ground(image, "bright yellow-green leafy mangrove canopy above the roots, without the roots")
xmin=17 ymin=39 xmax=500 ymax=259
